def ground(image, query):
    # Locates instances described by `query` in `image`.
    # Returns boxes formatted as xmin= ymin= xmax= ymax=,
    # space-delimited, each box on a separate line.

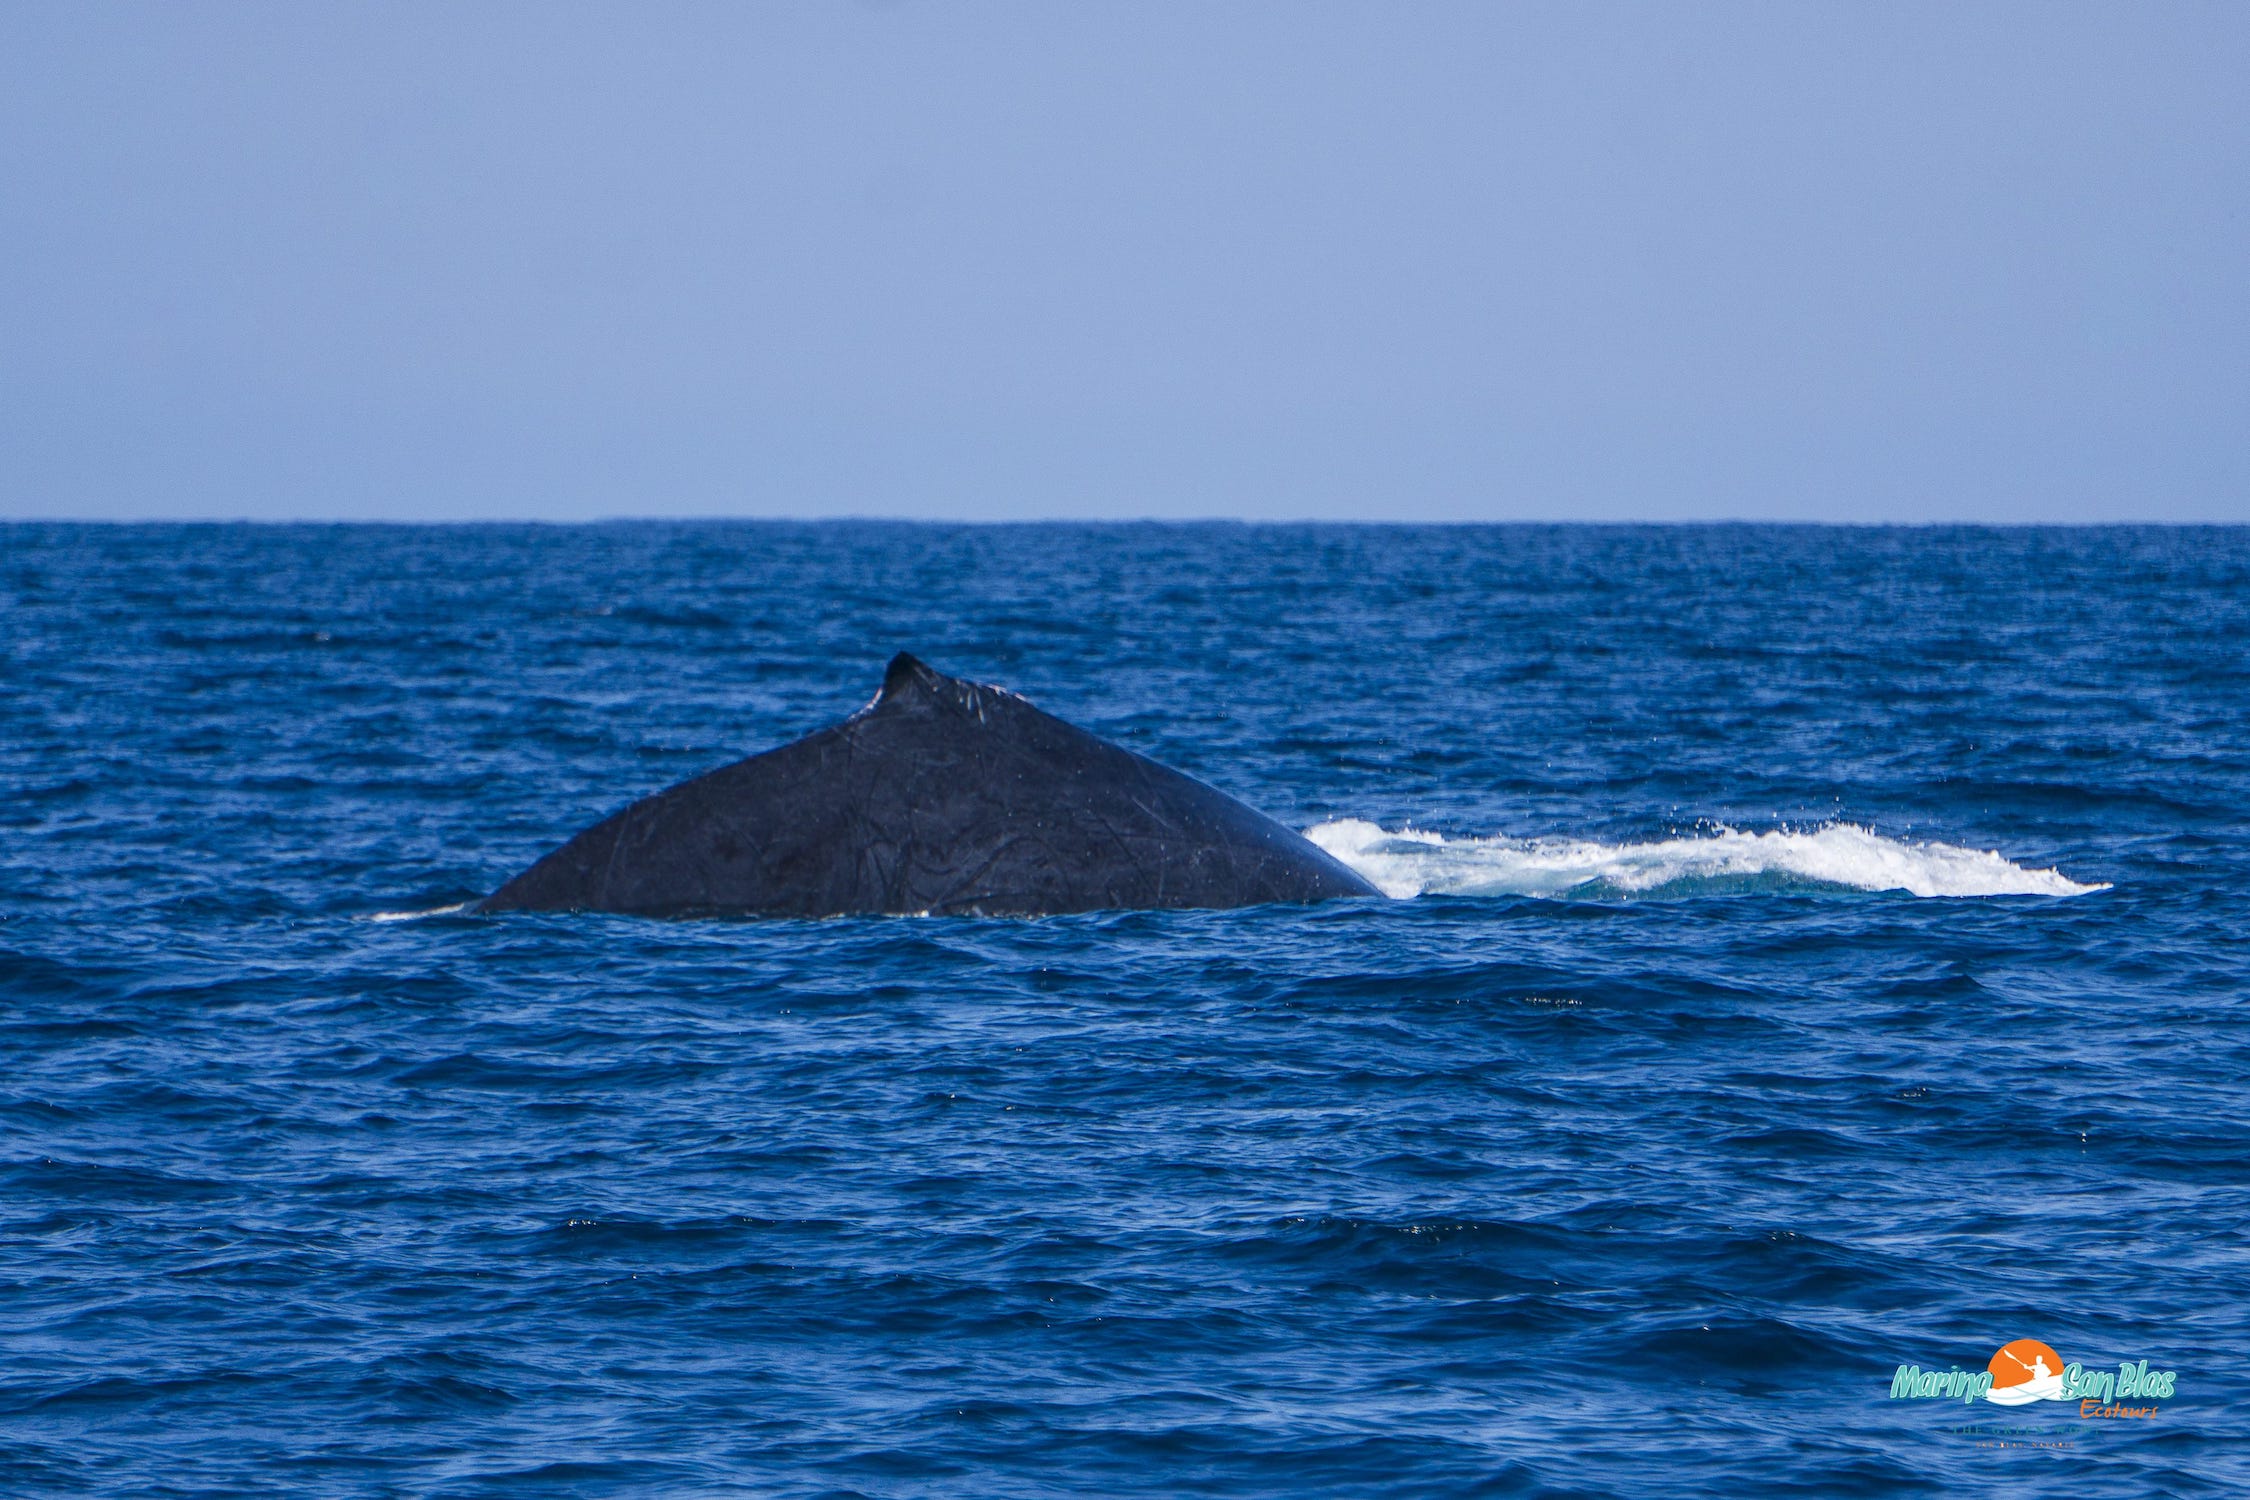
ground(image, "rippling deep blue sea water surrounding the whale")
xmin=0 ymin=524 xmax=2250 ymax=1496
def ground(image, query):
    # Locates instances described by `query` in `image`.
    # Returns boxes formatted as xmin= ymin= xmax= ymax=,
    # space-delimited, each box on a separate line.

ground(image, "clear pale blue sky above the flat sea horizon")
xmin=0 ymin=0 xmax=2250 ymax=522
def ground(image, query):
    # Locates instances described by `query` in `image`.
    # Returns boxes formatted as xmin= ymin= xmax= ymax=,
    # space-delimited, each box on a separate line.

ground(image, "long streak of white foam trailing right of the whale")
xmin=1305 ymin=819 xmax=2108 ymax=900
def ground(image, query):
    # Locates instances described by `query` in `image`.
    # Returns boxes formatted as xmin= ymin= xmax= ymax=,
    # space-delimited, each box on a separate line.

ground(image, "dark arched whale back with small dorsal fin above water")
xmin=475 ymin=652 xmax=1382 ymax=918
